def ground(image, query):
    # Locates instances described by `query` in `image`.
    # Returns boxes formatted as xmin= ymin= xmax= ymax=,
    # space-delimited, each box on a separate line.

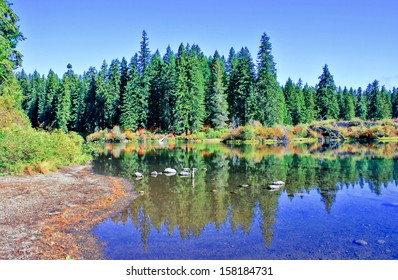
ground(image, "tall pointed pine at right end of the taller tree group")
xmin=255 ymin=33 xmax=287 ymax=126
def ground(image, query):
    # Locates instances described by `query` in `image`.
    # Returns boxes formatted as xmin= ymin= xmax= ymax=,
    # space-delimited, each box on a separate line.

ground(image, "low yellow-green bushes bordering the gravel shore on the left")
xmin=0 ymin=124 xmax=90 ymax=174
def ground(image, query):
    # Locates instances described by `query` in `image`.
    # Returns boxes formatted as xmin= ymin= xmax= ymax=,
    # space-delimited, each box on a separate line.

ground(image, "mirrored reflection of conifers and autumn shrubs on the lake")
xmin=94 ymin=143 xmax=398 ymax=258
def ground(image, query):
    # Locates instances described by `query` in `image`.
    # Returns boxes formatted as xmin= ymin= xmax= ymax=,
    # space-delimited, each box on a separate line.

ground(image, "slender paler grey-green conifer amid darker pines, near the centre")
xmin=207 ymin=51 xmax=228 ymax=129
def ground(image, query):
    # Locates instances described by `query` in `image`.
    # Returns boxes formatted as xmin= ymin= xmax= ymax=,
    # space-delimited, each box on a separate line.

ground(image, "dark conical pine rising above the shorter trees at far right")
xmin=315 ymin=65 xmax=340 ymax=120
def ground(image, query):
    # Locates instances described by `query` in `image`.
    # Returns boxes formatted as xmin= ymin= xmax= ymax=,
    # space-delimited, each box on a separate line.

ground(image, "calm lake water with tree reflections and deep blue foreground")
xmin=94 ymin=144 xmax=398 ymax=260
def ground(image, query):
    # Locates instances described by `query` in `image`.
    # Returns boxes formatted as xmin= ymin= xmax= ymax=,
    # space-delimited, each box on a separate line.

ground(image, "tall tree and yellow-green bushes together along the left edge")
xmin=0 ymin=0 xmax=90 ymax=175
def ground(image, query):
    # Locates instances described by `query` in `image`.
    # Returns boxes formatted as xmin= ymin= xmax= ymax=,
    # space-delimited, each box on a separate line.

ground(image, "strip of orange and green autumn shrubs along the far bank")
xmin=86 ymin=118 xmax=398 ymax=144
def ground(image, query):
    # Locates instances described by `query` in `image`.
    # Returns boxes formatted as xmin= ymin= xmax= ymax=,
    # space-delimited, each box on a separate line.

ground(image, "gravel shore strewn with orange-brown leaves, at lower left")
xmin=0 ymin=165 xmax=137 ymax=260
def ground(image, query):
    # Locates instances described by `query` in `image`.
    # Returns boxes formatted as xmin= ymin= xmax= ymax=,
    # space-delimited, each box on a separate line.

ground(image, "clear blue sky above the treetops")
xmin=11 ymin=0 xmax=398 ymax=89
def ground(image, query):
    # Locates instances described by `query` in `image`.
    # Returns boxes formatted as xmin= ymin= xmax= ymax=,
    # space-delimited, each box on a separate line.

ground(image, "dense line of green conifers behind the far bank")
xmin=17 ymin=31 xmax=398 ymax=133
